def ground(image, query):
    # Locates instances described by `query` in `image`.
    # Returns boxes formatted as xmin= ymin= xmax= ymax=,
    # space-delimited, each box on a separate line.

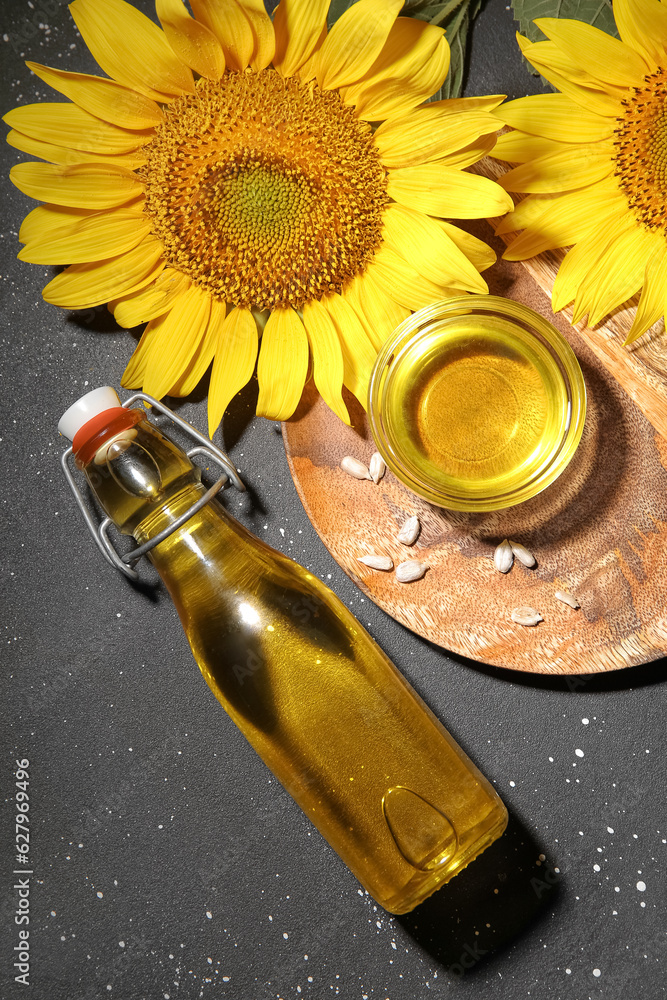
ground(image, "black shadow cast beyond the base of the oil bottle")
xmin=395 ymin=813 xmax=564 ymax=979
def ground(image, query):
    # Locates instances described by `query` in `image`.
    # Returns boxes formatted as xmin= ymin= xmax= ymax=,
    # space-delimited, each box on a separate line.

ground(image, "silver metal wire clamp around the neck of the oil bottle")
xmin=60 ymin=392 xmax=245 ymax=580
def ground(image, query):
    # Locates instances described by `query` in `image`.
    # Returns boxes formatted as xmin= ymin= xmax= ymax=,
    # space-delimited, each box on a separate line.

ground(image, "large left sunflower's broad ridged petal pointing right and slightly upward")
xmin=374 ymin=105 xmax=500 ymax=168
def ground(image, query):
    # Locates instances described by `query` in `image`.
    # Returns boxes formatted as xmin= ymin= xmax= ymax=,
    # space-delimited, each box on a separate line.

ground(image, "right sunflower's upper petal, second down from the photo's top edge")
xmin=535 ymin=17 xmax=646 ymax=88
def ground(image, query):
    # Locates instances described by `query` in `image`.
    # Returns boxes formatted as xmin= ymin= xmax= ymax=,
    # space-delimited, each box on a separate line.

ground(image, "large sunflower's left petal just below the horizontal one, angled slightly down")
xmin=18 ymin=212 xmax=151 ymax=264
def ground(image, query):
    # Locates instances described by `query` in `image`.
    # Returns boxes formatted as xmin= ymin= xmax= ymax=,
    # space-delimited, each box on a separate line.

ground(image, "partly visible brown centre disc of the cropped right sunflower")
xmin=614 ymin=69 xmax=667 ymax=234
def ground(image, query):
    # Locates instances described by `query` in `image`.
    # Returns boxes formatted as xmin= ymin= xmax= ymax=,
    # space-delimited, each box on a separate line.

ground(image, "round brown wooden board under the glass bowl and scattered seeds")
xmin=283 ymin=245 xmax=667 ymax=674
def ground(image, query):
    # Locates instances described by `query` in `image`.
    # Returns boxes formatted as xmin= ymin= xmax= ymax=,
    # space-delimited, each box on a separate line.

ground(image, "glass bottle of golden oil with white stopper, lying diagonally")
xmin=59 ymin=388 xmax=507 ymax=913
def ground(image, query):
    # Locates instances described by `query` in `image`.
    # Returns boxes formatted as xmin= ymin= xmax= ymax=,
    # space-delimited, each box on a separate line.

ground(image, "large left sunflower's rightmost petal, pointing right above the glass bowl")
xmin=387 ymin=163 xmax=514 ymax=219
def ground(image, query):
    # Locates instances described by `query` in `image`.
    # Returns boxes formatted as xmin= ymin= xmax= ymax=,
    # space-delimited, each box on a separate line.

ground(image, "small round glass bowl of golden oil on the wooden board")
xmin=368 ymin=295 xmax=586 ymax=511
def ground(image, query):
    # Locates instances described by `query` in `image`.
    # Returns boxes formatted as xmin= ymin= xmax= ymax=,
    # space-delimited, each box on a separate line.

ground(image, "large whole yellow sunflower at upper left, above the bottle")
xmin=5 ymin=0 xmax=511 ymax=434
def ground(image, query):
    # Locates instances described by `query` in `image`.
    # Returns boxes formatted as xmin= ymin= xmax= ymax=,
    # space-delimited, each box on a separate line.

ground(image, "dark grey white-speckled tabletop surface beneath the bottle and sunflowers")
xmin=0 ymin=0 xmax=667 ymax=1000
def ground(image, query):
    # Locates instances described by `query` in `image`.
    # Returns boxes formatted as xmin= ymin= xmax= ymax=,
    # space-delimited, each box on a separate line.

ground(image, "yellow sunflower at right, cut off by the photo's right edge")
xmin=493 ymin=0 xmax=667 ymax=343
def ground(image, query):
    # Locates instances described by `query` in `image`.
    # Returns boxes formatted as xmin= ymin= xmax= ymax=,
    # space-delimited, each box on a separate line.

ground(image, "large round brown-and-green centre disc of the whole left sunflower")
xmin=144 ymin=69 xmax=388 ymax=310
